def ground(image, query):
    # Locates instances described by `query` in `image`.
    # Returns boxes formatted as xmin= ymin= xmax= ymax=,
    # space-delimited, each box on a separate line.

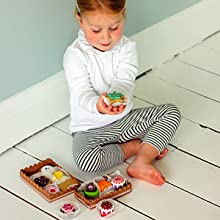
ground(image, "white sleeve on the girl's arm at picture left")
xmin=63 ymin=47 xmax=100 ymax=114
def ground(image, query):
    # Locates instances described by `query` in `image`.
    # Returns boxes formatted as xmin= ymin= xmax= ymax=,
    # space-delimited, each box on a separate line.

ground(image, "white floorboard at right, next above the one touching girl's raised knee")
xmin=153 ymin=58 xmax=220 ymax=103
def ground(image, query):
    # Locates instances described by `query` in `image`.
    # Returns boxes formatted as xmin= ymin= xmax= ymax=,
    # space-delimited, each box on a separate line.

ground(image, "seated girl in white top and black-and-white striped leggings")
xmin=64 ymin=0 xmax=180 ymax=185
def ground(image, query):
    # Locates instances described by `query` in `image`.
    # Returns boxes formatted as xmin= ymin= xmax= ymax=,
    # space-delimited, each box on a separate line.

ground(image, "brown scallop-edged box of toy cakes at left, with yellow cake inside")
xmin=20 ymin=159 xmax=80 ymax=202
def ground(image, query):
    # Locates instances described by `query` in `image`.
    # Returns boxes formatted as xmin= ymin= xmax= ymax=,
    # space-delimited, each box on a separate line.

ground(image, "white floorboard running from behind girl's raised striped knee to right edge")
xmin=135 ymin=71 xmax=220 ymax=130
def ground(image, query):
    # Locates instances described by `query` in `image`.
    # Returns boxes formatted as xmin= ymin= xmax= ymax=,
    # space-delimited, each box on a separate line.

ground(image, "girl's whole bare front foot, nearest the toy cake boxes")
xmin=127 ymin=161 xmax=165 ymax=185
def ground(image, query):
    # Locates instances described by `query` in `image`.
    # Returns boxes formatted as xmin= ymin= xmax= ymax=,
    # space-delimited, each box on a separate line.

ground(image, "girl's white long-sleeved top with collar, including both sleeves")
xmin=63 ymin=30 xmax=138 ymax=132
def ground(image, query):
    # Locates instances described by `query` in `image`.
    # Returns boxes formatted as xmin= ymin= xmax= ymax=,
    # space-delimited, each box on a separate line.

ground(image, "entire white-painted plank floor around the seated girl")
xmin=0 ymin=33 xmax=220 ymax=220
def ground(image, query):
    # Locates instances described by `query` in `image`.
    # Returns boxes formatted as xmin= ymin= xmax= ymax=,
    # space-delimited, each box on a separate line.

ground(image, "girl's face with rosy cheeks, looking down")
xmin=78 ymin=10 xmax=124 ymax=51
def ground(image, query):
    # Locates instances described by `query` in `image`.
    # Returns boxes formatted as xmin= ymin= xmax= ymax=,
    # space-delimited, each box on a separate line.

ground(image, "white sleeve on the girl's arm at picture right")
xmin=110 ymin=40 xmax=138 ymax=99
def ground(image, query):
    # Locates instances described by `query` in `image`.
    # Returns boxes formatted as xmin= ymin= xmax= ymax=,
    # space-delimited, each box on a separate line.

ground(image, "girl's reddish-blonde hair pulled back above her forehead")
xmin=75 ymin=0 xmax=126 ymax=16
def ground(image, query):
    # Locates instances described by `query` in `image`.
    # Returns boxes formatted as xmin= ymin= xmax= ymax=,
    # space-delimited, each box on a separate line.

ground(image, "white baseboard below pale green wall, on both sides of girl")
xmin=0 ymin=0 xmax=220 ymax=153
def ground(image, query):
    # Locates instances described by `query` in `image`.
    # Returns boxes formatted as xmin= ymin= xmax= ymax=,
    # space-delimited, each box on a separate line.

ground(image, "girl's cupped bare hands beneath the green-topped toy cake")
xmin=97 ymin=93 xmax=126 ymax=115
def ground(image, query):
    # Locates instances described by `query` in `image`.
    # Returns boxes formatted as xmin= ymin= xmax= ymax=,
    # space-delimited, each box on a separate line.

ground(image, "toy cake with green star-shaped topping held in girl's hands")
xmin=104 ymin=91 xmax=126 ymax=106
